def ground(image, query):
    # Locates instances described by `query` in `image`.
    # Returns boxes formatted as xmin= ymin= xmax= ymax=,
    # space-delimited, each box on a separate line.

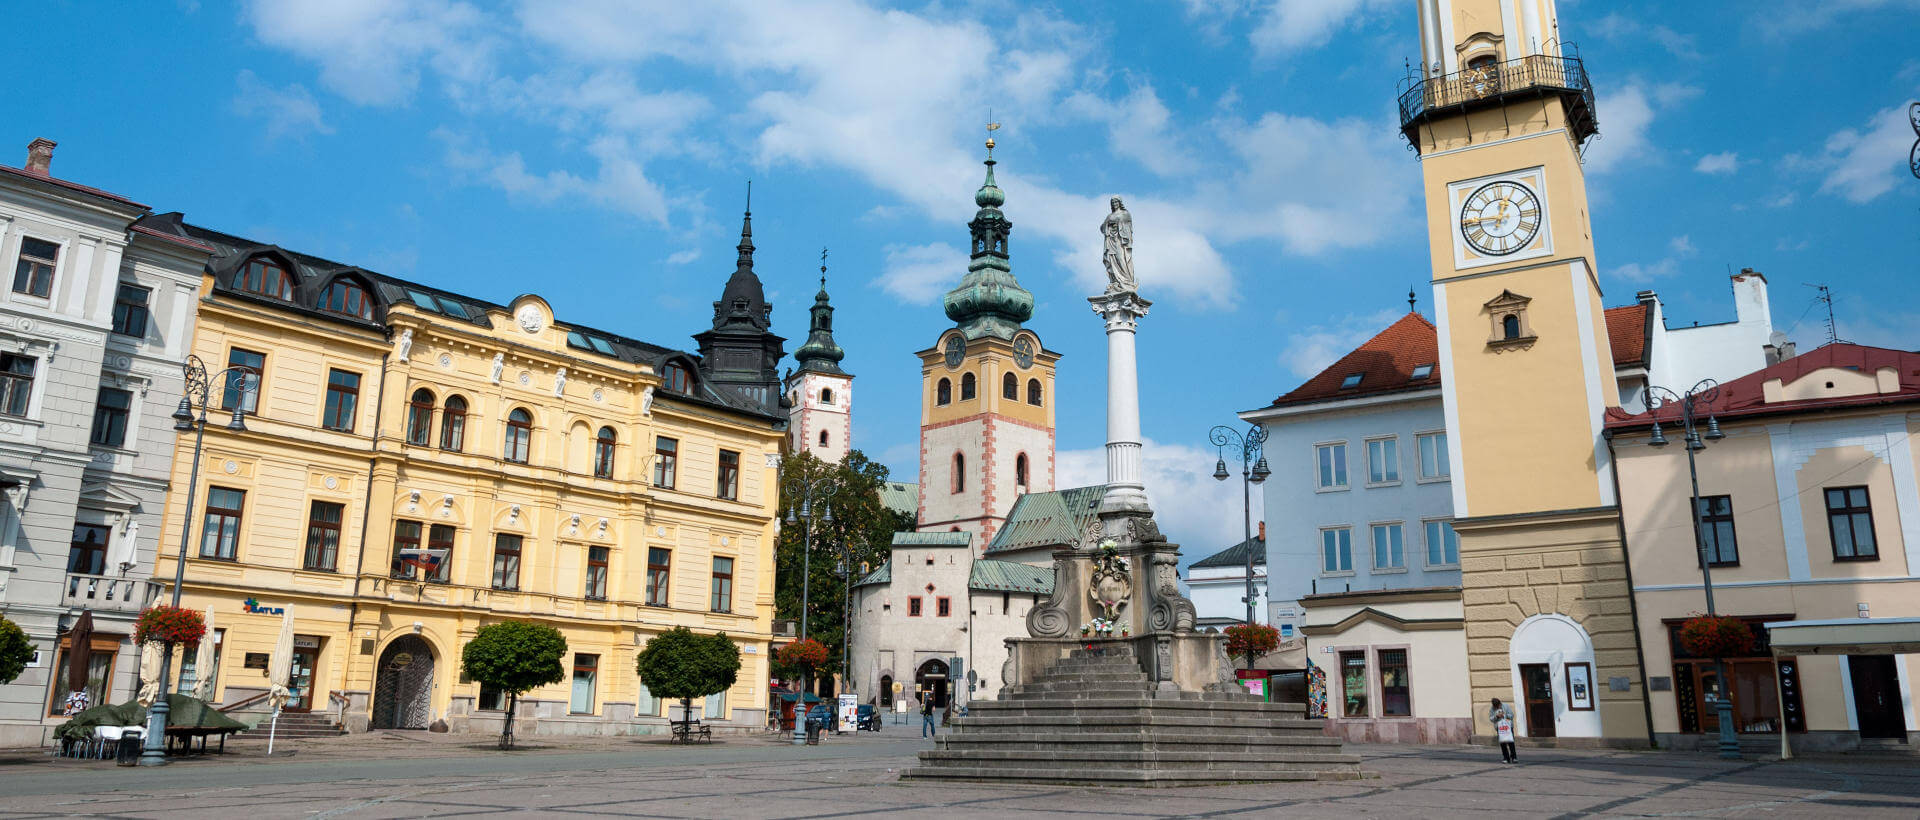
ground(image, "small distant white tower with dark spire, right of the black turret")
xmin=787 ymin=250 xmax=852 ymax=463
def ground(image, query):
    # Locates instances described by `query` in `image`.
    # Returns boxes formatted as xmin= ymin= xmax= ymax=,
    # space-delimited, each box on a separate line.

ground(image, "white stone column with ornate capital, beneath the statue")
xmin=1087 ymin=290 xmax=1152 ymax=517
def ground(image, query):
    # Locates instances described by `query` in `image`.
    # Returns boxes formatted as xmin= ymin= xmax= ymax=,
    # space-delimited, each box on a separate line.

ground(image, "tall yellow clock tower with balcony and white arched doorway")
xmin=1400 ymin=0 xmax=1649 ymax=743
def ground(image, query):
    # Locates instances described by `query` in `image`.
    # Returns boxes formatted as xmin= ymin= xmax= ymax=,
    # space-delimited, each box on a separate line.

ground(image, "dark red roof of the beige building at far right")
xmin=1607 ymin=342 xmax=1920 ymax=428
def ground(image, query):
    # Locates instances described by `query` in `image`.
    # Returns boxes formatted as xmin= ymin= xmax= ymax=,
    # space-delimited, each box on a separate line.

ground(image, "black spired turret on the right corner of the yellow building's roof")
xmin=693 ymin=205 xmax=785 ymax=413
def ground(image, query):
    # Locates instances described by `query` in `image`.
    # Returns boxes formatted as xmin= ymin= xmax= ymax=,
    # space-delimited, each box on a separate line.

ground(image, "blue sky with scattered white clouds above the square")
xmin=0 ymin=0 xmax=1920 ymax=559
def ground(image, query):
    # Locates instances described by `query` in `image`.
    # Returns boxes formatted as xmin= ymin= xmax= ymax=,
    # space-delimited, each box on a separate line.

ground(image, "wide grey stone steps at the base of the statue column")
xmin=900 ymin=649 xmax=1369 ymax=785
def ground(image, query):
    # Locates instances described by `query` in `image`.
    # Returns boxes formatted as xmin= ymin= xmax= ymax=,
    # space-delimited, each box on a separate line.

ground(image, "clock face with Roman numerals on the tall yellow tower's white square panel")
xmin=1448 ymin=167 xmax=1553 ymax=271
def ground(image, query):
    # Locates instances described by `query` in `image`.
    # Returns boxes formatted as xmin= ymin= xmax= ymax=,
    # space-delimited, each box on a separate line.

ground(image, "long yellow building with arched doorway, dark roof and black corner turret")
xmin=140 ymin=212 xmax=785 ymax=734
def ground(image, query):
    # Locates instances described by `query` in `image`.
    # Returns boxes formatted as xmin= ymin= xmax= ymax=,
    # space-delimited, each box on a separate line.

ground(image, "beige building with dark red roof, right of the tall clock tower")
xmin=1607 ymin=344 xmax=1920 ymax=749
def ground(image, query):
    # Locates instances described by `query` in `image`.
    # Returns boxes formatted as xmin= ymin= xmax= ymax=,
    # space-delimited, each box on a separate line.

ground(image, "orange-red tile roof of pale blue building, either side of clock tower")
xmin=1271 ymin=303 xmax=1649 ymax=407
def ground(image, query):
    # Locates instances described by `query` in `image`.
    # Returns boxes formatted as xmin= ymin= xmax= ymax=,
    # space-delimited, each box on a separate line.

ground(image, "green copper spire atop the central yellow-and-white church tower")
xmin=943 ymin=130 xmax=1033 ymax=338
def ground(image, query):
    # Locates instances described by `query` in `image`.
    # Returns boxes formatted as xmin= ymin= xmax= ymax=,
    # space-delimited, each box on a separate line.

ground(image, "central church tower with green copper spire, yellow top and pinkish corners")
xmin=918 ymin=138 xmax=1060 ymax=549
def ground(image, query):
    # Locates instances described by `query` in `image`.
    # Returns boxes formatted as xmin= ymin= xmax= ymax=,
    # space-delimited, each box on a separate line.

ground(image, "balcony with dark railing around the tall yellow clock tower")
xmin=1400 ymin=46 xmax=1599 ymax=150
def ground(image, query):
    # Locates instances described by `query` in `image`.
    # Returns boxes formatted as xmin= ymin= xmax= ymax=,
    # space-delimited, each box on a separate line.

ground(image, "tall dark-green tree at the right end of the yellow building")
xmin=774 ymin=449 xmax=914 ymax=687
